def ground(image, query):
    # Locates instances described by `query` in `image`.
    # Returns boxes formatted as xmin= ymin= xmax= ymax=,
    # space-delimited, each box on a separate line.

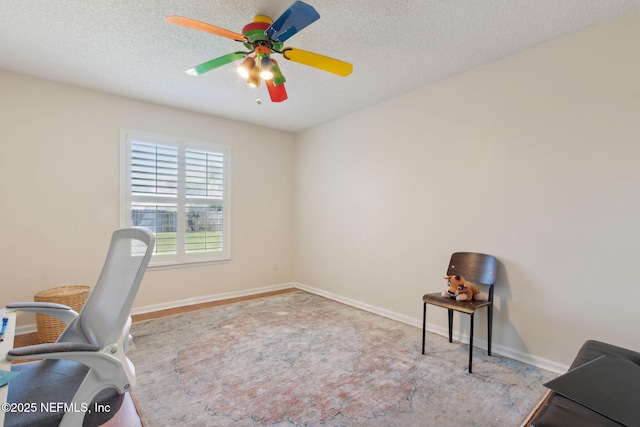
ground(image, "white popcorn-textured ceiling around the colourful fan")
xmin=0 ymin=0 xmax=640 ymax=132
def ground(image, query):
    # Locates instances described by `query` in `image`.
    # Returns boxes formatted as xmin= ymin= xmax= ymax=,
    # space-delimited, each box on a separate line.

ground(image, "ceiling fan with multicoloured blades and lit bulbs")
xmin=165 ymin=1 xmax=353 ymax=102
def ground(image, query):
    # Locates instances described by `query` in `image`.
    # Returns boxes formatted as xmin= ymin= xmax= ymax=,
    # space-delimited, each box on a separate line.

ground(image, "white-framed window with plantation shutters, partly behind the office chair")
xmin=120 ymin=130 xmax=230 ymax=265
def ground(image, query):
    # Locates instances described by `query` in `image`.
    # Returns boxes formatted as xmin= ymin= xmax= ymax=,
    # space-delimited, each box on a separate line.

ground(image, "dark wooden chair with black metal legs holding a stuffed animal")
xmin=422 ymin=252 xmax=497 ymax=373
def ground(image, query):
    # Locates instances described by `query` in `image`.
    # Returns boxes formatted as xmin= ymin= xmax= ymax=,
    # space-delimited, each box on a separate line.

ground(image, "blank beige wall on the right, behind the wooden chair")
xmin=295 ymin=12 xmax=640 ymax=368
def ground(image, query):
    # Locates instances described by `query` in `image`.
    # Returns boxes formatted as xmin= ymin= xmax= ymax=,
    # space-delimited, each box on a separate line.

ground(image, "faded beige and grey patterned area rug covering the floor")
xmin=129 ymin=291 xmax=555 ymax=427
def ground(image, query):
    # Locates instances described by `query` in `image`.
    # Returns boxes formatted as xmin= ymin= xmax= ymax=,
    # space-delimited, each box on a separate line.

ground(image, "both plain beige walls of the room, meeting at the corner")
xmin=0 ymin=8 xmax=640 ymax=369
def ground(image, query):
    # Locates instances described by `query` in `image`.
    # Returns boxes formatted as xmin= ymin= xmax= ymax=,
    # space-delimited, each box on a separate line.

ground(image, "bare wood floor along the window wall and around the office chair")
xmin=14 ymin=288 xmax=297 ymax=427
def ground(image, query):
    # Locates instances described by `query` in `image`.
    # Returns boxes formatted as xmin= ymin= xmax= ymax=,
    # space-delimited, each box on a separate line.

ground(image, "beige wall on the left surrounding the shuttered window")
xmin=0 ymin=71 xmax=294 ymax=324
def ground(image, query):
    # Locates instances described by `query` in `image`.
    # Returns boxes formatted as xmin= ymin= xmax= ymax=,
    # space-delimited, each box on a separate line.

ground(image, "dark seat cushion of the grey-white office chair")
xmin=4 ymin=360 xmax=124 ymax=427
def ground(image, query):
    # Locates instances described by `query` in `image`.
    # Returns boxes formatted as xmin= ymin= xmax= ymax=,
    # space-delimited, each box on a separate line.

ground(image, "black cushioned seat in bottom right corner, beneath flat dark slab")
xmin=531 ymin=340 xmax=640 ymax=427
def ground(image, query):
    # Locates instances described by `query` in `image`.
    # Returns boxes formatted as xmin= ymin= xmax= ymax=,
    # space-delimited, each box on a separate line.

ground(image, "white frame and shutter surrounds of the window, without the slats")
xmin=119 ymin=129 xmax=231 ymax=268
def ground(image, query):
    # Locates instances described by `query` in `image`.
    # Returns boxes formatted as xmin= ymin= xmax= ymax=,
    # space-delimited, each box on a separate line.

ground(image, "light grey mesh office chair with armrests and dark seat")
xmin=5 ymin=229 xmax=155 ymax=427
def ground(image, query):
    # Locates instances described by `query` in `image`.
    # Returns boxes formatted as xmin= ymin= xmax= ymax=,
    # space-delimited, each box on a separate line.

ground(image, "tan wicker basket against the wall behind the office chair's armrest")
xmin=33 ymin=286 xmax=91 ymax=343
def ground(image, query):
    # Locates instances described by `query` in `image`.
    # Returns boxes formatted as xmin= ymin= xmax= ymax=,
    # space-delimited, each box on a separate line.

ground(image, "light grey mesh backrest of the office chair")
xmin=78 ymin=229 xmax=155 ymax=348
